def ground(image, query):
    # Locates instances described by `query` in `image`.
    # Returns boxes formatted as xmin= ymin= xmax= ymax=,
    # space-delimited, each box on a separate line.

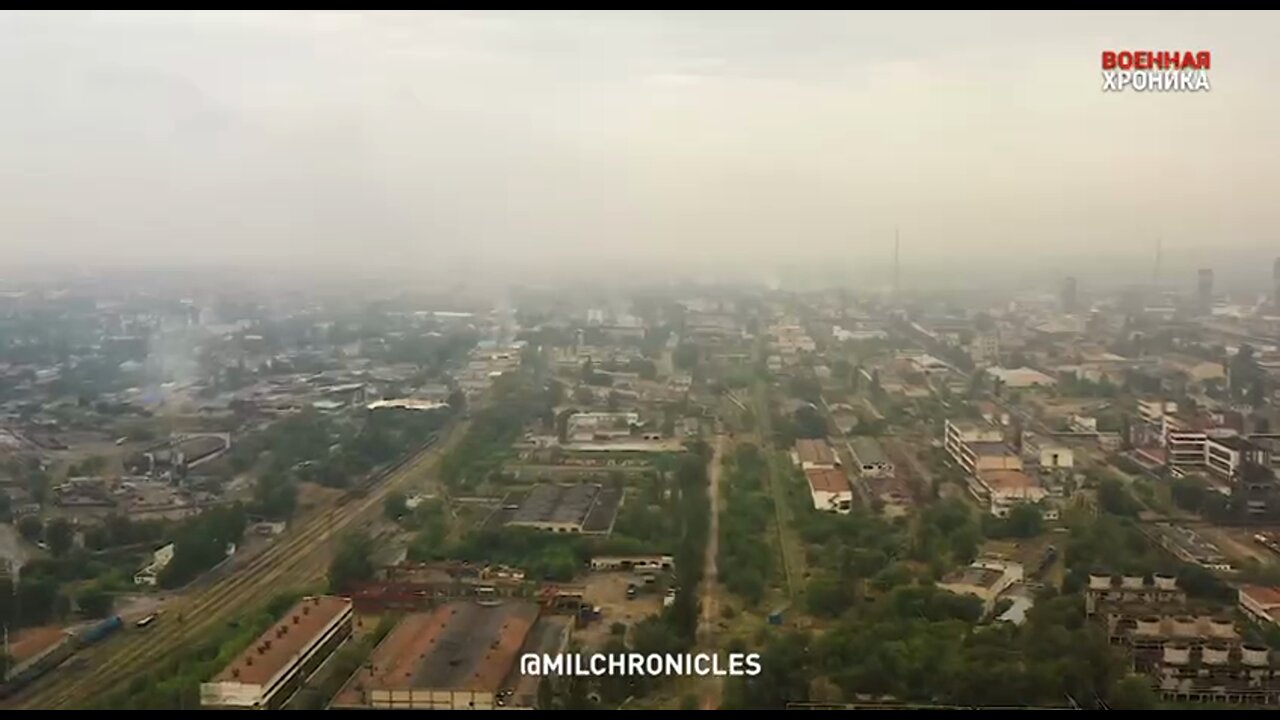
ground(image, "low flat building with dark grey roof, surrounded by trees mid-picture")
xmin=489 ymin=484 xmax=622 ymax=536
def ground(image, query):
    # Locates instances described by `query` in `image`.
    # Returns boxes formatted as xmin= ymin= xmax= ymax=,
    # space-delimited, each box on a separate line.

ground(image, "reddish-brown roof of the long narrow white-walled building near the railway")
xmin=212 ymin=596 xmax=351 ymax=685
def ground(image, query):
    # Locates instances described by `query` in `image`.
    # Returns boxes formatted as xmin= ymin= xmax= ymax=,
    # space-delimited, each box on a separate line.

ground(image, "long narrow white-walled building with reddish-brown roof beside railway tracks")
xmin=200 ymin=596 xmax=352 ymax=710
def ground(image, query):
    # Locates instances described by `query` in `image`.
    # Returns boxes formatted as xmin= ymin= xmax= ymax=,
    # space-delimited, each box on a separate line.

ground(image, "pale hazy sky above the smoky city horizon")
xmin=0 ymin=13 xmax=1280 ymax=280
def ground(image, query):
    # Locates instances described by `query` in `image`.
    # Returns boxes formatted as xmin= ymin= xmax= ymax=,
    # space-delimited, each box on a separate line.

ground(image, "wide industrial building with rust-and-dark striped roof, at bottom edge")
xmin=333 ymin=600 xmax=572 ymax=710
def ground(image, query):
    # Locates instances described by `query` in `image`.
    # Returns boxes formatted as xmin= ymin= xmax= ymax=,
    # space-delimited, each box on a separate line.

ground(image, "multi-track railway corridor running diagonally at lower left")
xmin=15 ymin=423 xmax=467 ymax=710
